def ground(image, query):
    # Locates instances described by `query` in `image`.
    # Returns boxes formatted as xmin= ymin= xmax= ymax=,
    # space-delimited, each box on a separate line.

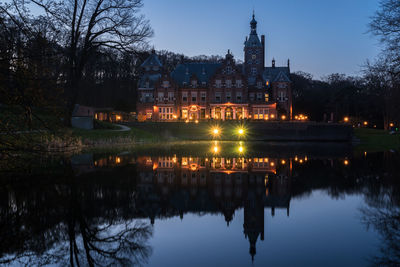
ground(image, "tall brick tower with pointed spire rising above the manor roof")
xmin=244 ymin=14 xmax=265 ymax=81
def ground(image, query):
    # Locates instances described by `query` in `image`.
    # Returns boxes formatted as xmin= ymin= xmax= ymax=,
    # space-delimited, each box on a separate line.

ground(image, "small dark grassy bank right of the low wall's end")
xmin=354 ymin=128 xmax=400 ymax=152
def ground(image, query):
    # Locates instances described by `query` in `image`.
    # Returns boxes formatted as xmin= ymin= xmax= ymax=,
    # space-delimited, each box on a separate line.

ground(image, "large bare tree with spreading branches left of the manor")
xmin=2 ymin=0 xmax=153 ymax=122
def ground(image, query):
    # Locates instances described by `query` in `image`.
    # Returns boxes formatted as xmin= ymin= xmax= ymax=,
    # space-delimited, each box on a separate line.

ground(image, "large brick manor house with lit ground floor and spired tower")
xmin=137 ymin=14 xmax=292 ymax=122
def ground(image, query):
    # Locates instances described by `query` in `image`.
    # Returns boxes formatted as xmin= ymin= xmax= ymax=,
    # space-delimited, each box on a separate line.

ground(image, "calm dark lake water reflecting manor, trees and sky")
xmin=0 ymin=142 xmax=400 ymax=266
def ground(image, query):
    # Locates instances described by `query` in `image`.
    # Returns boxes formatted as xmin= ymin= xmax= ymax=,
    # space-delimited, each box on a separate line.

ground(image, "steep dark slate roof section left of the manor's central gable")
xmin=171 ymin=63 xmax=222 ymax=85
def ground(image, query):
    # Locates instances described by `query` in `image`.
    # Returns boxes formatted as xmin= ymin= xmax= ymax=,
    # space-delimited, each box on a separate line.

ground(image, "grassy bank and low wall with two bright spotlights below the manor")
xmin=74 ymin=121 xmax=352 ymax=149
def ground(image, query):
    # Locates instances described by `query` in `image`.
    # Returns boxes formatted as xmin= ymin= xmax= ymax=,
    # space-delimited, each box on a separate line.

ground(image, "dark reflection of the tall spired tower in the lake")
xmin=243 ymin=188 xmax=264 ymax=261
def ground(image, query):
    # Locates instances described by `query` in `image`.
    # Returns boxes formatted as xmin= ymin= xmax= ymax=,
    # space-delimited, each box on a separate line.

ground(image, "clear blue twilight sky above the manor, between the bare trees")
xmin=142 ymin=0 xmax=379 ymax=78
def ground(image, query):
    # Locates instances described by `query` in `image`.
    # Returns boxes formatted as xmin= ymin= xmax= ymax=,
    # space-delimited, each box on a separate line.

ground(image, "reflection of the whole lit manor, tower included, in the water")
xmin=137 ymin=157 xmax=291 ymax=258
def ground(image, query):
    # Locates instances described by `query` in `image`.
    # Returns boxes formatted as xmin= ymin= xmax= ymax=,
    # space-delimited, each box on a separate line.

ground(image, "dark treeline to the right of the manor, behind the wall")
xmin=291 ymin=71 xmax=400 ymax=128
